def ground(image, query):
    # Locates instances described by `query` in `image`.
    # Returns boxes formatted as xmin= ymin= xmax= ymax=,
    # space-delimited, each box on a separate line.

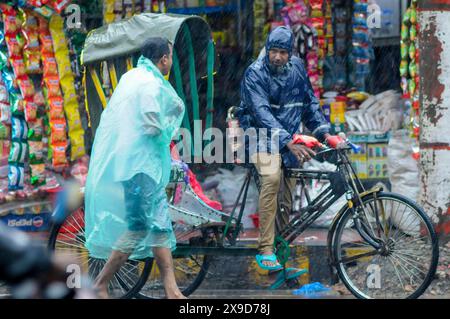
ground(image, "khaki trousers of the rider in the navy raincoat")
xmin=251 ymin=153 xmax=295 ymax=252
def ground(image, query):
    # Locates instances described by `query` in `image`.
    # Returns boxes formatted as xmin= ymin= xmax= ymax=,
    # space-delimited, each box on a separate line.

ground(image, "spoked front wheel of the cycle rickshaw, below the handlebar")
xmin=332 ymin=192 xmax=439 ymax=299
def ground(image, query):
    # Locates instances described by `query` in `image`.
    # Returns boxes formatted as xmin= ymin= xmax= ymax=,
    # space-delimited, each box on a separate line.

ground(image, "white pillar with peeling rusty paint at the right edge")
xmin=418 ymin=0 xmax=450 ymax=241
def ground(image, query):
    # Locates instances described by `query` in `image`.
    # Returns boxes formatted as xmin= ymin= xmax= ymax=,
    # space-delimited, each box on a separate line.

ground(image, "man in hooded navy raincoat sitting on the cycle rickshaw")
xmin=237 ymin=27 xmax=343 ymax=272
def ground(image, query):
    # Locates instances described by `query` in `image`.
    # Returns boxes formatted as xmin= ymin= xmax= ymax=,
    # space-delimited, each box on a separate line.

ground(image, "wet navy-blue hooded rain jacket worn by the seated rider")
xmin=237 ymin=27 xmax=330 ymax=167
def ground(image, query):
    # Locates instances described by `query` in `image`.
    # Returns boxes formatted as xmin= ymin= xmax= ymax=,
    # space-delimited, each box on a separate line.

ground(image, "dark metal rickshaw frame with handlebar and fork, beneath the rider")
xmin=174 ymin=148 xmax=381 ymax=257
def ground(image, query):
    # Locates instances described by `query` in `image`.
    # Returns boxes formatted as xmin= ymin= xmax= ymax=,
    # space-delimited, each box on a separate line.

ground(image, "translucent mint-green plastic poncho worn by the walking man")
xmin=85 ymin=56 xmax=184 ymax=259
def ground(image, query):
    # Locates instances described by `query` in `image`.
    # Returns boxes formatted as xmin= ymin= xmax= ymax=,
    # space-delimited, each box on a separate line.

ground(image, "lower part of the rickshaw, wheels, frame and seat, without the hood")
xmin=48 ymin=143 xmax=439 ymax=298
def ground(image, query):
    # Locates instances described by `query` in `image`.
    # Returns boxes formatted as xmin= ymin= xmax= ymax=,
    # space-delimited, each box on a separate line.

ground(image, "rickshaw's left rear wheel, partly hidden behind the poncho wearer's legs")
xmin=48 ymin=209 xmax=153 ymax=299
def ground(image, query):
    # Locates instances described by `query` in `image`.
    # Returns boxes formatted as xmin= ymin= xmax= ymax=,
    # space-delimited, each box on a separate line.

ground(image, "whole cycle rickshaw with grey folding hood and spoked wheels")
xmin=48 ymin=13 xmax=439 ymax=298
